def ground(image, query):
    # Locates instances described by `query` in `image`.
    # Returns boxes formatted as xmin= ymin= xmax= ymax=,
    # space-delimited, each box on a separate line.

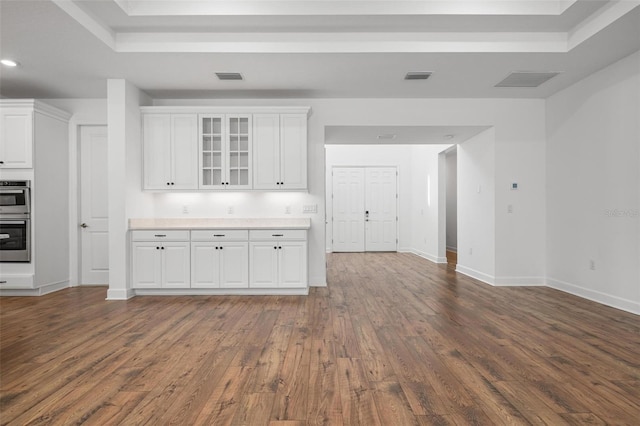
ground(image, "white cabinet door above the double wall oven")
xmin=0 ymin=108 xmax=33 ymax=169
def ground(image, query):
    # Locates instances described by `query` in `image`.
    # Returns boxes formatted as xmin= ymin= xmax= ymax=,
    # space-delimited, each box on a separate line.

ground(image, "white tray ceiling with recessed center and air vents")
xmin=0 ymin=0 xmax=640 ymax=99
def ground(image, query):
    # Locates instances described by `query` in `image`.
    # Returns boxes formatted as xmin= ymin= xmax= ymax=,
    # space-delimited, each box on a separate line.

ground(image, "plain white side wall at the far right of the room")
xmin=546 ymin=52 xmax=640 ymax=314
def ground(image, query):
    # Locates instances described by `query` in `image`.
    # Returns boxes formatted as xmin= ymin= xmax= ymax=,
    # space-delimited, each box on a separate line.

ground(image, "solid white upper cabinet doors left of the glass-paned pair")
xmin=142 ymin=114 xmax=198 ymax=189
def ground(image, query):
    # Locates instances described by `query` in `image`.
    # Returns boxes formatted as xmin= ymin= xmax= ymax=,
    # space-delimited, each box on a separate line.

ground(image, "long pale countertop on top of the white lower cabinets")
xmin=129 ymin=218 xmax=311 ymax=230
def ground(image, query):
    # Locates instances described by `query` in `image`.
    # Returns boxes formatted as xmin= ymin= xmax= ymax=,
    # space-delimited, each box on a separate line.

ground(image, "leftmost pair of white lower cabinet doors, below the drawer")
xmin=133 ymin=241 xmax=190 ymax=288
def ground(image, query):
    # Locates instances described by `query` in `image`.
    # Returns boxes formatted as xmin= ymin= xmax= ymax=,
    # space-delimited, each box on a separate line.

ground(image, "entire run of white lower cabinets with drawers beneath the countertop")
xmin=131 ymin=229 xmax=308 ymax=294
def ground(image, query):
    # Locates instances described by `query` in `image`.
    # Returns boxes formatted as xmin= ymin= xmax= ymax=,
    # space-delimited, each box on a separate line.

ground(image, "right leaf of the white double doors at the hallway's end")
xmin=365 ymin=167 xmax=397 ymax=251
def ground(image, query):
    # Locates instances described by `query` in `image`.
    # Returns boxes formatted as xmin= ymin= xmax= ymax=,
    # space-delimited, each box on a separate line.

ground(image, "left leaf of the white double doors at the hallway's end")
xmin=332 ymin=167 xmax=365 ymax=252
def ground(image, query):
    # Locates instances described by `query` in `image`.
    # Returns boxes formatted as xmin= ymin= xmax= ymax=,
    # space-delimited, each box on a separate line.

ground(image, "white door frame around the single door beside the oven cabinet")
xmin=69 ymin=115 xmax=109 ymax=287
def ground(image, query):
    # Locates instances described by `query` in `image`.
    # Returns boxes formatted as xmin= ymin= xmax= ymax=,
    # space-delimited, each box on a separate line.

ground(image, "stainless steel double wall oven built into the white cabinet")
xmin=0 ymin=180 xmax=31 ymax=262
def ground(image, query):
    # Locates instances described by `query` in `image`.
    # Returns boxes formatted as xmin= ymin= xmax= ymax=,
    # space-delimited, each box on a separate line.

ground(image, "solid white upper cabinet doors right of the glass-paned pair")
xmin=253 ymin=114 xmax=307 ymax=190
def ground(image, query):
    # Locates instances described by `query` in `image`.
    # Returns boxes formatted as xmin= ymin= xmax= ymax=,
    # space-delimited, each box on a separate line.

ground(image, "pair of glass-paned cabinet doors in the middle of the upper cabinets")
xmin=200 ymin=115 xmax=251 ymax=189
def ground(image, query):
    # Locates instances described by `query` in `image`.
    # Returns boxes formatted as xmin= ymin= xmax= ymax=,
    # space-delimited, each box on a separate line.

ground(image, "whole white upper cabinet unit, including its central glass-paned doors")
xmin=141 ymin=107 xmax=309 ymax=190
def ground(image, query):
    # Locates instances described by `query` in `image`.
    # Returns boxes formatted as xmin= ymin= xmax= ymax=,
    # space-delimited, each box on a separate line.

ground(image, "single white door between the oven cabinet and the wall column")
xmin=80 ymin=126 xmax=109 ymax=285
